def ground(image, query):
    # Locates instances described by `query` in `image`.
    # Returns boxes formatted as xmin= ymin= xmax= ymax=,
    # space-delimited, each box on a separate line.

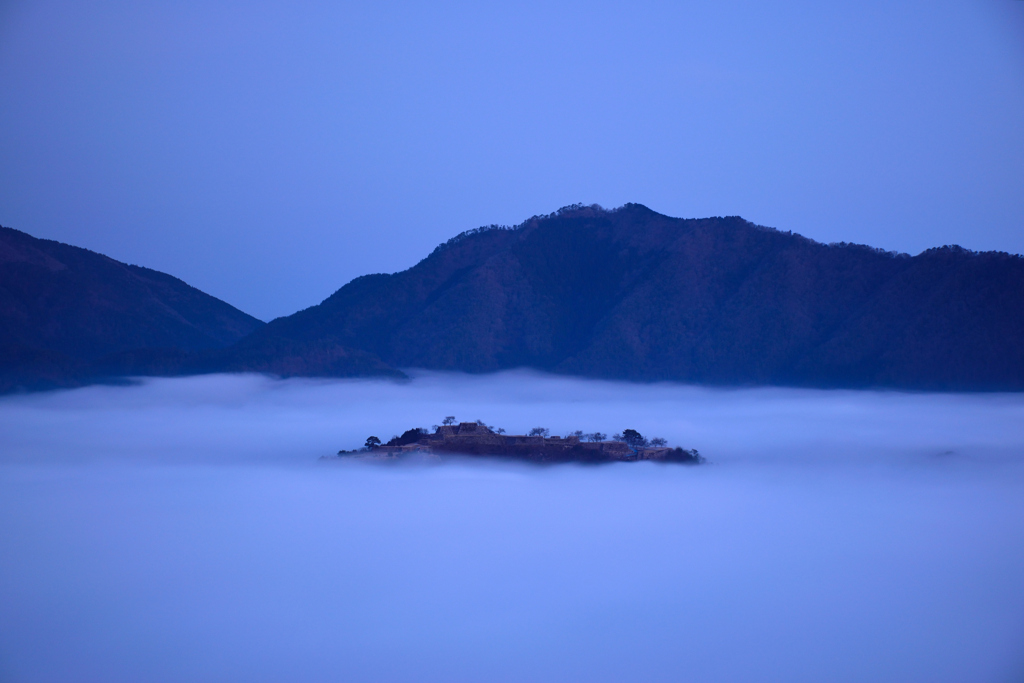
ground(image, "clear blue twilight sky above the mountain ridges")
xmin=0 ymin=0 xmax=1024 ymax=319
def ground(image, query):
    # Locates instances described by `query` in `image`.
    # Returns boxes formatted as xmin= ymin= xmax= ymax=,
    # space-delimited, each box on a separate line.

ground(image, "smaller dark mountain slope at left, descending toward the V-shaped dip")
xmin=0 ymin=227 xmax=263 ymax=391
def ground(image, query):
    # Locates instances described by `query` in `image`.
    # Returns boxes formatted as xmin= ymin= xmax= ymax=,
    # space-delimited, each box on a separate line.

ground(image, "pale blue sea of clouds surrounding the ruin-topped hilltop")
xmin=0 ymin=373 xmax=1024 ymax=682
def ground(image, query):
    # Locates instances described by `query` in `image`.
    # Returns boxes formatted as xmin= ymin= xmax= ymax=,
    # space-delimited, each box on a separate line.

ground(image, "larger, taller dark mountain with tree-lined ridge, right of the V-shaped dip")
xmin=232 ymin=204 xmax=1024 ymax=390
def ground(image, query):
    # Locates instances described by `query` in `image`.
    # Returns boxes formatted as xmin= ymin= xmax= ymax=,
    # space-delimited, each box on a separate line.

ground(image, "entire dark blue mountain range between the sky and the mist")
xmin=0 ymin=204 xmax=1024 ymax=391
